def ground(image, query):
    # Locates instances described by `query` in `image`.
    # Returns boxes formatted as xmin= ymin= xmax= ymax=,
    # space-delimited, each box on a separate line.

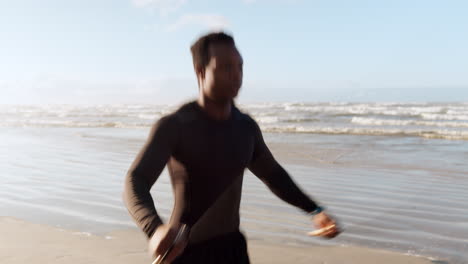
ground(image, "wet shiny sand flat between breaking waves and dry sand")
xmin=0 ymin=128 xmax=468 ymax=264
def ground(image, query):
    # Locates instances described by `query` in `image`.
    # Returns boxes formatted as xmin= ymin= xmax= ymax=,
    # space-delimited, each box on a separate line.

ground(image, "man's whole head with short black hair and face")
xmin=190 ymin=32 xmax=243 ymax=101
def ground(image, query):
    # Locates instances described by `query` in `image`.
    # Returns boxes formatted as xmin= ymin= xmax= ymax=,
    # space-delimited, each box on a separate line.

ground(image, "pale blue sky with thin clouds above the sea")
xmin=0 ymin=0 xmax=468 ymax=104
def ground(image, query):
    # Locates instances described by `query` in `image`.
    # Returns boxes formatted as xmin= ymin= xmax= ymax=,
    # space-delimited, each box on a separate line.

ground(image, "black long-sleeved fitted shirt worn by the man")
xmin=123 ymin=101 xmax=317 ymax=243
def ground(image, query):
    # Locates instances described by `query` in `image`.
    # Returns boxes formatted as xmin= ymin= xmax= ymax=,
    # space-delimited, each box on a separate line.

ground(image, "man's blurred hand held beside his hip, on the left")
xmin=148 ymin=224 xmax=189 ymax=264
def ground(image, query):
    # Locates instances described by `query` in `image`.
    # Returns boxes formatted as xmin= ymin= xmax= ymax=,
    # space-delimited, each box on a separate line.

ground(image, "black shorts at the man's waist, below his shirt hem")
xmin=172 ymin=231 xmax=250 ymax=264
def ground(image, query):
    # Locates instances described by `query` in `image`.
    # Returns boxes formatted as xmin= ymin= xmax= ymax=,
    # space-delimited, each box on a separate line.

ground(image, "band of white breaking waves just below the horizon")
xmin=0 ymin=103 xmax=468 ymax=140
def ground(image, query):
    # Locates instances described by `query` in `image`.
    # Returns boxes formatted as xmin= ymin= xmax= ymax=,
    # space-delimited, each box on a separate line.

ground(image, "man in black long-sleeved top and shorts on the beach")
xmin=124 ymin=33 xmax=340 ymax=264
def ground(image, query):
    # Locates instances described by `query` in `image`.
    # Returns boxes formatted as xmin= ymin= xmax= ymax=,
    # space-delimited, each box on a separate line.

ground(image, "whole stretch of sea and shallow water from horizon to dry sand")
xmin=0 ymin=102 xmax=468 ymax=263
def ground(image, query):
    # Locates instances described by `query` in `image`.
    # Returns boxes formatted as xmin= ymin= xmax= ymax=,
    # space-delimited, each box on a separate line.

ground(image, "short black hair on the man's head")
xmin=190 ymin=32 xmax=235 ymax=71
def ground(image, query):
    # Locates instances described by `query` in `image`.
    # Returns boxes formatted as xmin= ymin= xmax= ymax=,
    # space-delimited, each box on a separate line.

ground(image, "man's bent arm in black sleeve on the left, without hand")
xmin=123 ymin=116 xmax=178 ymax=239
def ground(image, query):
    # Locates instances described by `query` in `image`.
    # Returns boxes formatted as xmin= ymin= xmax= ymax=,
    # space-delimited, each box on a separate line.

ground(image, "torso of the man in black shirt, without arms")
xmin=164 ymin=102 xmax=255 ymax=243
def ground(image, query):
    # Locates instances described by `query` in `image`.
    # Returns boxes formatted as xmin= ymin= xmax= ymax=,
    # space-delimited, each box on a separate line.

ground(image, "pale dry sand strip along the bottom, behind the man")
xmin=0 ymin=217 xmax=441 ymax=264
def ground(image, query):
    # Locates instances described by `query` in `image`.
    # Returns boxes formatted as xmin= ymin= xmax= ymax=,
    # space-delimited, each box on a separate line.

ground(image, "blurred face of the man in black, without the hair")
xmin=202 ymin=44 xmax=243 ymax=101
